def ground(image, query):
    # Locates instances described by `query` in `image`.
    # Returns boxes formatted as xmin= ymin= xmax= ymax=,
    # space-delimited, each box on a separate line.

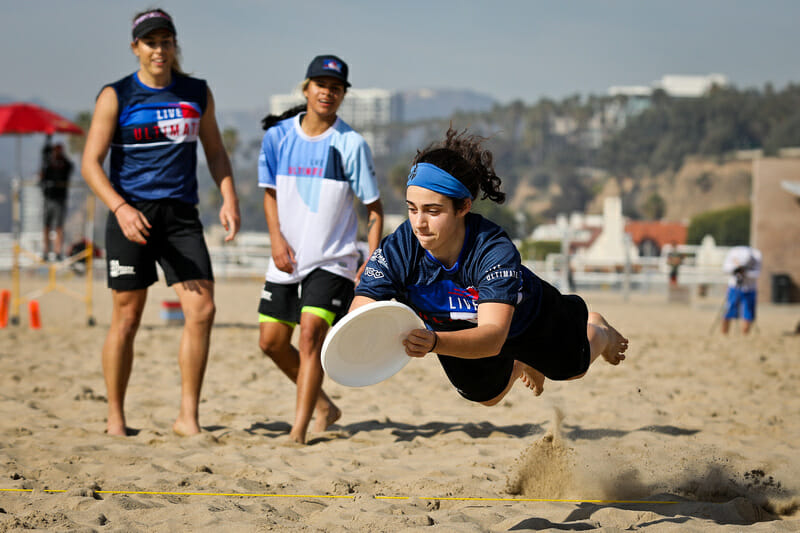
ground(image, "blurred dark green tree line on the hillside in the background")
xmin=71 ymin=84 xmax=800 ymax=242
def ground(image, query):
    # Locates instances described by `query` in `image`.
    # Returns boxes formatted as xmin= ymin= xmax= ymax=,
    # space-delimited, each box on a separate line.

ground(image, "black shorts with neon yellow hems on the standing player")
xmin=258 ymin=268 xmax=355 ymax=326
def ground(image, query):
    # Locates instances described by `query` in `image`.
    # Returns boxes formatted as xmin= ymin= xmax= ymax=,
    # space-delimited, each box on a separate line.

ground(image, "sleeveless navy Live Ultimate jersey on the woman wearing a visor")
xmin=103 ymin=73 xmax=207 ymax=204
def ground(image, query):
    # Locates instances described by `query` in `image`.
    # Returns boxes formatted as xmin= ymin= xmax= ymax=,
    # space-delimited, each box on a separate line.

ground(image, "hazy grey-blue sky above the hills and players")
xmin=0 ymin=0 xmax=800 ymax=112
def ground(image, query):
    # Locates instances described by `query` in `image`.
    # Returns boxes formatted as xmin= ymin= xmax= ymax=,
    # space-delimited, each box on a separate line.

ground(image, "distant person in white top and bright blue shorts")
xmin=722 ymin=246 xmax=761 ymax=334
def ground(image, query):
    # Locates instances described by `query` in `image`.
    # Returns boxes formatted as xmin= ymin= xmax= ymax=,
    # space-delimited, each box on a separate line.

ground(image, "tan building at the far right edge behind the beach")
xmin=750 ymin=157 xmax=800 ymax=302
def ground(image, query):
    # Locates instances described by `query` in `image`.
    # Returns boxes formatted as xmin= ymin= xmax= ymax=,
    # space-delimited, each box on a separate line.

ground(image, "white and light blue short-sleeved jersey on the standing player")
xmin=258 ymin=114 xmax=380 ymax=284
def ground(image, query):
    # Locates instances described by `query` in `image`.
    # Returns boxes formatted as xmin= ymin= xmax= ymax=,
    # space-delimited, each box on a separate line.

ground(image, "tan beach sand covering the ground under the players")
xmin=0 ymin=278 xmax=800 ymax=532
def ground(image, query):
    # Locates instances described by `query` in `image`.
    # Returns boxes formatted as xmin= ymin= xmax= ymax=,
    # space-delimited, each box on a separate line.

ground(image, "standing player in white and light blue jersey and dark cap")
xmin=258 ymin=55 xmax=383 ymax=443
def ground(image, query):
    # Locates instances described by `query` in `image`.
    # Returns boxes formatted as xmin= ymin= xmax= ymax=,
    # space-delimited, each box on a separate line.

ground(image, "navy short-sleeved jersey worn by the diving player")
xmin=355 ymin=213 xmax=541 ymax=338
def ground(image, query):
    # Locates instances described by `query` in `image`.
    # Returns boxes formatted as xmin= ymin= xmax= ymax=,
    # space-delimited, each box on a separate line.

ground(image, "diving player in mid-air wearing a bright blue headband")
xmin=350 ymin=129 xmax=628 ymax=405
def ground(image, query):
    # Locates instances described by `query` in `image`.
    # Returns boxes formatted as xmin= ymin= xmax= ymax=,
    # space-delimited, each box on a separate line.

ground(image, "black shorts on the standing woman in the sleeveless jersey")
xmin=106 ymin=200 xmax=214 ymax=291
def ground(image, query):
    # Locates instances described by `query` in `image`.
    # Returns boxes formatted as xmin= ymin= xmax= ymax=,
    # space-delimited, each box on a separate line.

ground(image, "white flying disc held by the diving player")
xmin=322 ymin=302 xmax=425 ymax=387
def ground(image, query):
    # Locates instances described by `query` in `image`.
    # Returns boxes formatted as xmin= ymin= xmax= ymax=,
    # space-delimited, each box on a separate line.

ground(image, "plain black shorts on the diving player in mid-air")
xmin=439 ymin=281 xmax=591 ymax=402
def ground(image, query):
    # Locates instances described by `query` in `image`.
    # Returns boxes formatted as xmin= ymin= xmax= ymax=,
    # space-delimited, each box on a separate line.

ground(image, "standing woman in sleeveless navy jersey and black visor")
xmin=82 ymin=9 xmax=244 ymax=435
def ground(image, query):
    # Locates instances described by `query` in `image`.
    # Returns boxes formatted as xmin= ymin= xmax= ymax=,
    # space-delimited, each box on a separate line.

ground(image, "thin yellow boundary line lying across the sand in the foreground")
xmin=0 ymin=488 xmax=680 ymax=504
